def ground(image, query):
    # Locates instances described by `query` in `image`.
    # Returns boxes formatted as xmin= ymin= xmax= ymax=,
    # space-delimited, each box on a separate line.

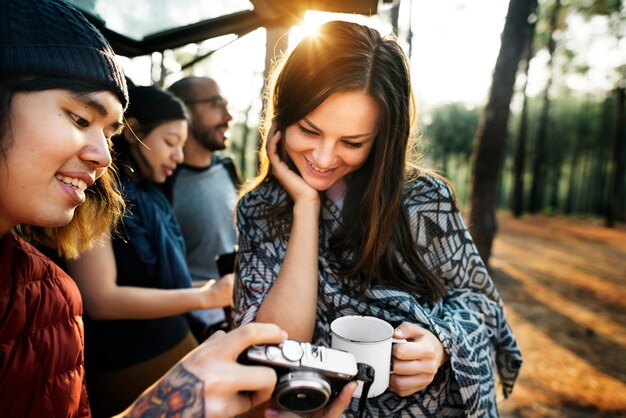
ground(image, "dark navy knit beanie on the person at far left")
xmin=0 ymin=0 xmax=128 ymax=108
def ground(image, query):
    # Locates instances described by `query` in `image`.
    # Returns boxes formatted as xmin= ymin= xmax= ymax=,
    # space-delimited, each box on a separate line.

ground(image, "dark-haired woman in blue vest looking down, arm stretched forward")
xmin=67 ymin=86 xmax=233 ymax=417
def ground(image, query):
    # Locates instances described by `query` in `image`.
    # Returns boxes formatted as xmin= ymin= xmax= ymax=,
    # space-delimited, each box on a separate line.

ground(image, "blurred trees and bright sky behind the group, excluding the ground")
xmin=118 ymin=0 xmax=626 ymax=261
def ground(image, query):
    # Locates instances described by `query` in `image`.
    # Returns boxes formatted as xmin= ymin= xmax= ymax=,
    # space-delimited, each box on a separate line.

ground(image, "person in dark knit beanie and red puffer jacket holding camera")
xmin=0 ymin=0 xmax=355 ymax=418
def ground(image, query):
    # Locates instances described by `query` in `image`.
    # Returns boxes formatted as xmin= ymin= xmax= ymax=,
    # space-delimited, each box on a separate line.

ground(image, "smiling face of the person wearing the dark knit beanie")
xmin=0 ymin=90 xmax=122 ymax=236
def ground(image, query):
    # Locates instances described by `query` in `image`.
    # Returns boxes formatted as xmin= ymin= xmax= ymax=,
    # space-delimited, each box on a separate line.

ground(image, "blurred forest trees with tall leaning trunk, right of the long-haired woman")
xmin=425 ymin=0 xmax=626 ymax=263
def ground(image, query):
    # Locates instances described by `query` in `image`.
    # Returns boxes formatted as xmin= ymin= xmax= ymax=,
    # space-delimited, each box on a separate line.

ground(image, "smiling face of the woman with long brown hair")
xmin=284 ymin=91 xmax=379 ymax=191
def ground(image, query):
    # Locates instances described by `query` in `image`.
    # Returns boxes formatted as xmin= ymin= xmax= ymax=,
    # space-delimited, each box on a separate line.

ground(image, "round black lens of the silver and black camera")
xmin=276 ymin=371 xmax=331 ymax=412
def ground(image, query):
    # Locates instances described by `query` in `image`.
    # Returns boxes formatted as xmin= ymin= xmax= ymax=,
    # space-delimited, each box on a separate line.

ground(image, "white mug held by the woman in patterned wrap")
xmin=330 ymin=315 xmax=406 ymax=398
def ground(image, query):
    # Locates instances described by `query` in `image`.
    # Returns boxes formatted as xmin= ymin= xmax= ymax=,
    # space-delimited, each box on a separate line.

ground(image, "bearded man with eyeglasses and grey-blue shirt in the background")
xmin=165 ymin=77 xmax=239 ymax=341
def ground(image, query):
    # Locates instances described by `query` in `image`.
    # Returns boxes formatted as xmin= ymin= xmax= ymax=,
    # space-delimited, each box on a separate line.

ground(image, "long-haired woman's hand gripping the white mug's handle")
xmin=389 ymin=322 xmax=448 ymax=396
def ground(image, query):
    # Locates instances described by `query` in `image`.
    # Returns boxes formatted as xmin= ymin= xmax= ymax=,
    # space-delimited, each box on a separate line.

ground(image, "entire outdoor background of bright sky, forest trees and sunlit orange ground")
xmin=89 ymin=0 xmax=626 ymax=417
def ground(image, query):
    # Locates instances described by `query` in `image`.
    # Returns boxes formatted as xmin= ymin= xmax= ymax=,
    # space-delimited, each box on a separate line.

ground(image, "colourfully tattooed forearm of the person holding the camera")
xmin=119 ymin=364 xmax=205 ymax=418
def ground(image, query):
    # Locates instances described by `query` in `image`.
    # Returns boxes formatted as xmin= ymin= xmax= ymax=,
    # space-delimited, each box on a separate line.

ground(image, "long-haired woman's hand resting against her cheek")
xmin=266 ymin=125 xmax=319 ymax=203
